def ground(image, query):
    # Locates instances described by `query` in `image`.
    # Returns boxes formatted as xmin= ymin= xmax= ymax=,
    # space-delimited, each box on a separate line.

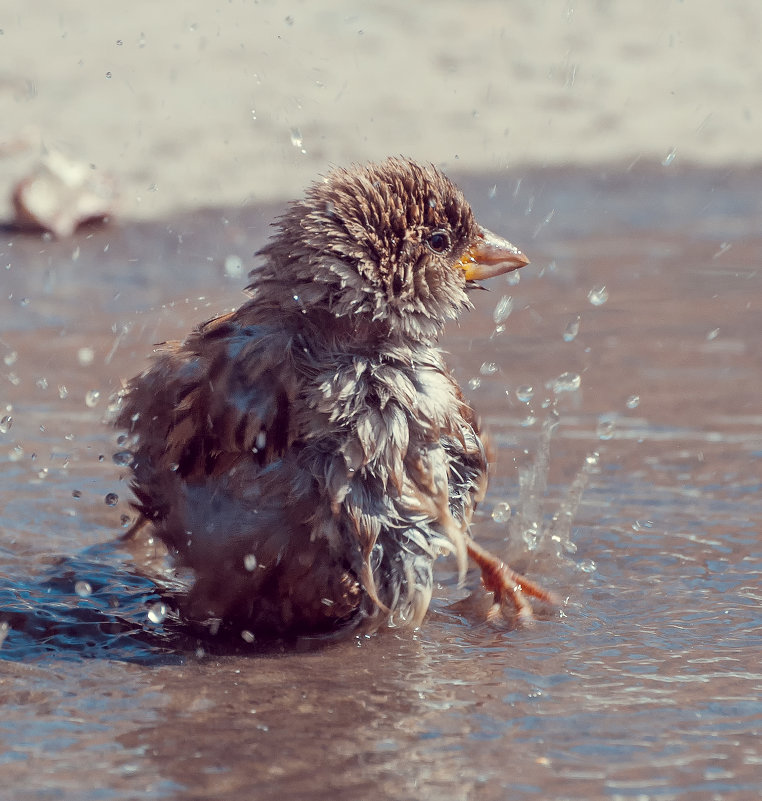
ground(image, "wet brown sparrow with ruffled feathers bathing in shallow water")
xmin=116 ymin=158 xmax=552 ymax=637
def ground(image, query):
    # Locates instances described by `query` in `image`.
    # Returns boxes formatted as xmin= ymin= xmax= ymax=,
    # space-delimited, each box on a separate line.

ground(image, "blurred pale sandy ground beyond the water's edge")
xmin=0 ymin=0 xmax=762 ymax=217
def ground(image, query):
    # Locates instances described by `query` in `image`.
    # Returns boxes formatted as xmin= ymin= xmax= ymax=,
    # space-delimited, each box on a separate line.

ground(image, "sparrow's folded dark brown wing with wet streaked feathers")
xmin=115 ymin=313 xmax=297 ymax=519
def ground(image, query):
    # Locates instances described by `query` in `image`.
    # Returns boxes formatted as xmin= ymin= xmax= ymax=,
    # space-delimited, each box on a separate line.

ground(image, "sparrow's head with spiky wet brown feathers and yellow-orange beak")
xmin=250 ymin=158 xmax=528 ymax=339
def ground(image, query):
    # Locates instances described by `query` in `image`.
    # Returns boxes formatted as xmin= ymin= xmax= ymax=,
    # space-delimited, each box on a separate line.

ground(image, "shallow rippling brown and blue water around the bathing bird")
xmin=0 ymin=169 xmax=762 ymax=801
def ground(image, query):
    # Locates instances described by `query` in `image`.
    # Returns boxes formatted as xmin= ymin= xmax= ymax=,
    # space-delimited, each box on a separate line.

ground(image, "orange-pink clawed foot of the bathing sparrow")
xmin=467 ymin=540 xmax=559 ymax=624
